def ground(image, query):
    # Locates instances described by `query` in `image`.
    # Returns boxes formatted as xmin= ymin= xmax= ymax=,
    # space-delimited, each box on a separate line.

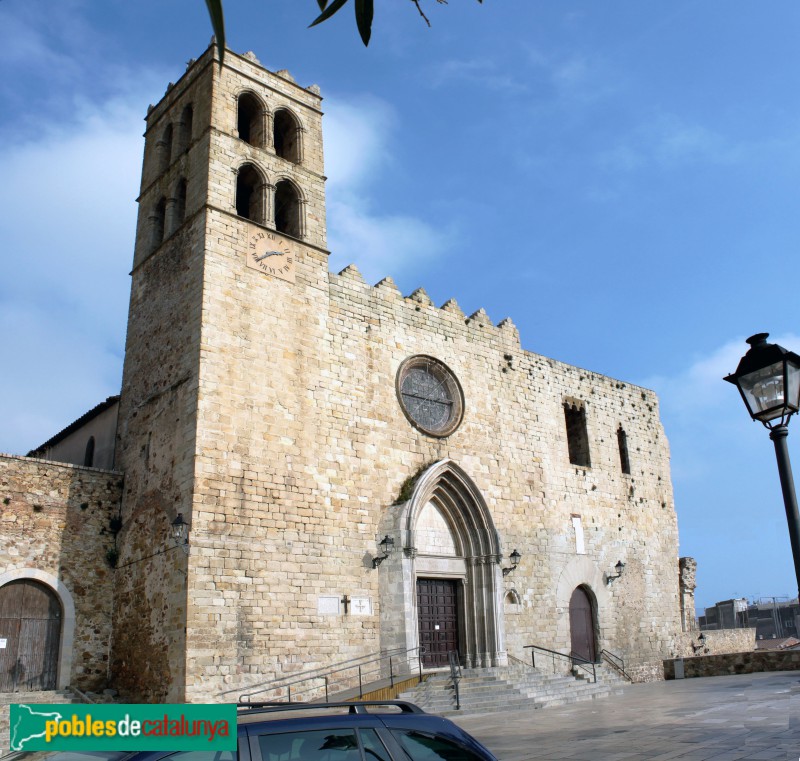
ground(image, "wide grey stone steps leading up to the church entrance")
xmin=399 ymin=665 xmax=625 ymax=716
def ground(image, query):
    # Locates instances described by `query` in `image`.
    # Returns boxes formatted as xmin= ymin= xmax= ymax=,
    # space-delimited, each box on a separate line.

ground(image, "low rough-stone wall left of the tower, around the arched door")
xmin=0 ymin=455 xmax=122 ymax=690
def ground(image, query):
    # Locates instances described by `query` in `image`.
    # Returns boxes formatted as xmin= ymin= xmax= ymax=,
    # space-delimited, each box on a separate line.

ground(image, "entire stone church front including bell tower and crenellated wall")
xmin=0 ymin=48 xmax=693 ymax=701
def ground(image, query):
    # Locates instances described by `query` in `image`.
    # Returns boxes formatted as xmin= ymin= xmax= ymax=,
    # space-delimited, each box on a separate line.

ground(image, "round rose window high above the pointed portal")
xmin=397 ymin=356 xmax=464 ymax=437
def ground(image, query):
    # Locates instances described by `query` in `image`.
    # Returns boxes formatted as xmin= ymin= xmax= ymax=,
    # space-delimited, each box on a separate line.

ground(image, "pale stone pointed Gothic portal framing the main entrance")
xmin=380 ymin=460 xmax=506 ymax=668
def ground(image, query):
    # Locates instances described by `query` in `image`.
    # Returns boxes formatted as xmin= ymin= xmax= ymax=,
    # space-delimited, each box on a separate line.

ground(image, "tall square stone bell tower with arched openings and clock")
xmin=112 ymin=47 xmax=327 ymax=701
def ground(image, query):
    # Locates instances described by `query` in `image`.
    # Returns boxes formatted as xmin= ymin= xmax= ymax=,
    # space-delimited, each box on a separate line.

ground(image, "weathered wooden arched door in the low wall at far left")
xmin=0 ymin=579 xmax=62 ymax=692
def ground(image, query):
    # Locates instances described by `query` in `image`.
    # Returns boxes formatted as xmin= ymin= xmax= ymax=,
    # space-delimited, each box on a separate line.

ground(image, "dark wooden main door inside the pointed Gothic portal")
xmin=417 ymin=579 xmax=458 ymax=668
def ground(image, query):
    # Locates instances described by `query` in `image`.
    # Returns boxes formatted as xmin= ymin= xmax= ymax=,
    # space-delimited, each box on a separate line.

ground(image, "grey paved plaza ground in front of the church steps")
xmin=451 ymin=671 xmax=800 ymax=761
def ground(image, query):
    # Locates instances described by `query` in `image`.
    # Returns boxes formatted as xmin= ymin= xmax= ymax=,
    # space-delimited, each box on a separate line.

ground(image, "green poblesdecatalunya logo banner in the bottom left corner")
xmin=9 ymin=703 xmax=236 ymax=751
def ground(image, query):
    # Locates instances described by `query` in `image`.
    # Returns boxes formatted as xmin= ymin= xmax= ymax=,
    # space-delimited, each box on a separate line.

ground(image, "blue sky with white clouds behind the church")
xmin=0 ymin=0 xmax=800 ymax=606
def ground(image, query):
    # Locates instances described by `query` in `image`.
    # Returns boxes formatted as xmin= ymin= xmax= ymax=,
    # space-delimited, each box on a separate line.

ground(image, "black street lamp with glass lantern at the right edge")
xmin=723 ymin=333 xmax=800 ymax=598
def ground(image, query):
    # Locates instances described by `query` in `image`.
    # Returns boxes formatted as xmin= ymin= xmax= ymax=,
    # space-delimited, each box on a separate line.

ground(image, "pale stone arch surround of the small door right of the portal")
xmin=552 ymin=556 xmax=613 ymax=653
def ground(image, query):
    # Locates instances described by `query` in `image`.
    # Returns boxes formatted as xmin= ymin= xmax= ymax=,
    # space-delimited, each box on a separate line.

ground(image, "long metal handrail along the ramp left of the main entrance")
xmin=234 ymin=647 xmax=425 ymax=704
